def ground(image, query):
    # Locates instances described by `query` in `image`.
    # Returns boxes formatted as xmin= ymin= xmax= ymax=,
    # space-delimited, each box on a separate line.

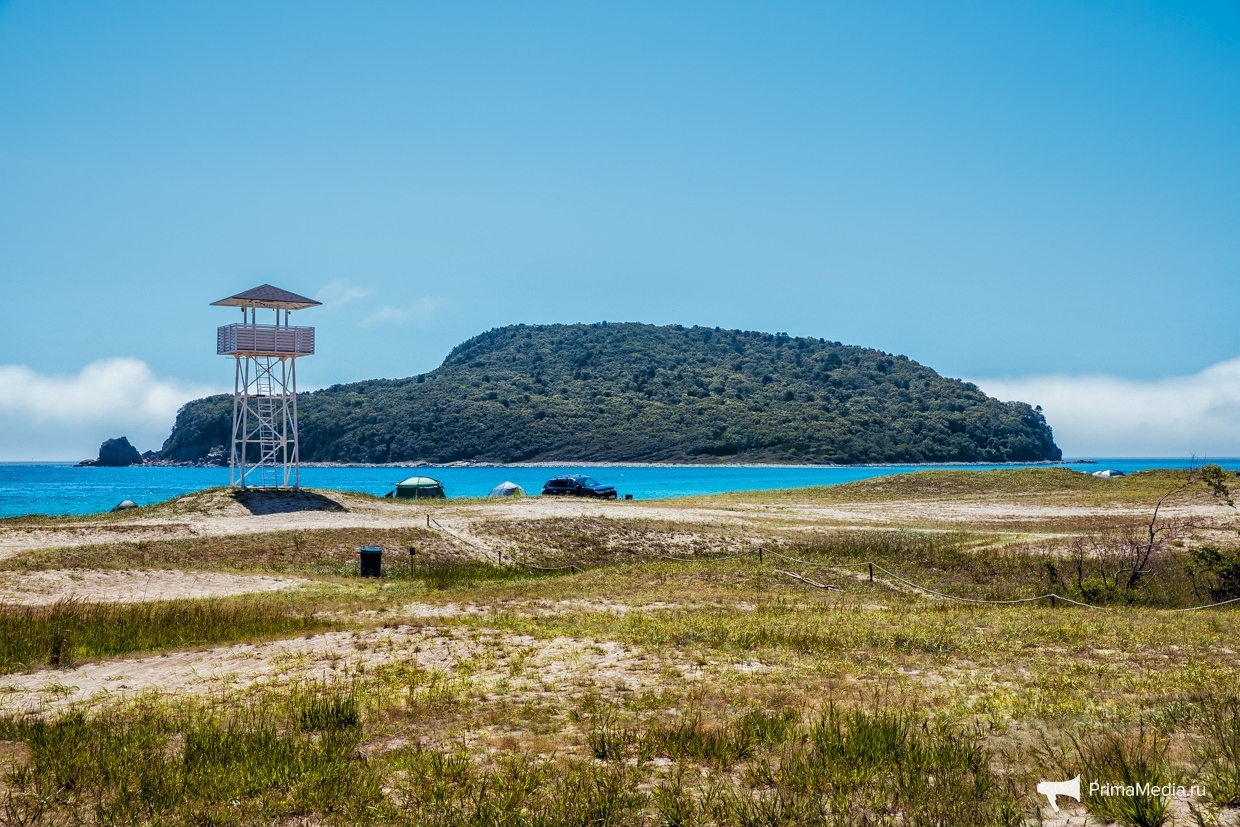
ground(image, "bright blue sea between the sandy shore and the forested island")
xmin=0 ymin=459 xmax=1240 ymax=517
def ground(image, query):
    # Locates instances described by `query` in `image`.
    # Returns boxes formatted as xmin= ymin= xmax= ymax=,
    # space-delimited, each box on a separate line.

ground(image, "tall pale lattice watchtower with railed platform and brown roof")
xmin=211 ymin=284 xmax=321 ymax=489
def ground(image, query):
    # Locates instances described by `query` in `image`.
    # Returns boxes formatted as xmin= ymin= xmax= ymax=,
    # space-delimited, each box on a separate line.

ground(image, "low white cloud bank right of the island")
xmin=973 ymin=358 xmax=1240 ymax=458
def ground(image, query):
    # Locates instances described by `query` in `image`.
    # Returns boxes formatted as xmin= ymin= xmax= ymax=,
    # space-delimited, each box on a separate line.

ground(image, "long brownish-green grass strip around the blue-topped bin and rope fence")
xmin=7 ymin=517 xmax=1231 ymax=608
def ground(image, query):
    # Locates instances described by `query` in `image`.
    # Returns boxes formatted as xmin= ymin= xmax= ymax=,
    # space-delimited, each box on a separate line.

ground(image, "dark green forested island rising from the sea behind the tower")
xmin=161 ymin=322 xmax=1060 ymax=462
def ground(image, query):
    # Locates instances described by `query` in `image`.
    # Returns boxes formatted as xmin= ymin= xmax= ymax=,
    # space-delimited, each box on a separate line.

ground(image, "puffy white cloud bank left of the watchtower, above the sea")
xmin=0 ymin=358 xmax=221 ymax=460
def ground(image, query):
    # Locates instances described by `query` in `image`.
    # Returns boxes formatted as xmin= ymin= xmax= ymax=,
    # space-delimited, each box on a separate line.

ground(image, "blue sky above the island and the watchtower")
xmin=0 ymin=0 xmax=1240 ymax=459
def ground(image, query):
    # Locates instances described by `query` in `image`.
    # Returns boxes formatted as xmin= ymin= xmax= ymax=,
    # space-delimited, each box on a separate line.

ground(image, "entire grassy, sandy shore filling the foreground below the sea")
xmin=0 ymin=469 xmax=1240 ymax=827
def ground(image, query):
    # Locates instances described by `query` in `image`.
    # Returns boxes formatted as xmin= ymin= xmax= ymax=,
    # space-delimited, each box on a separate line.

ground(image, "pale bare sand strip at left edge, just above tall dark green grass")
xmin=0 ymin=569 xmax=309 ymax=606
